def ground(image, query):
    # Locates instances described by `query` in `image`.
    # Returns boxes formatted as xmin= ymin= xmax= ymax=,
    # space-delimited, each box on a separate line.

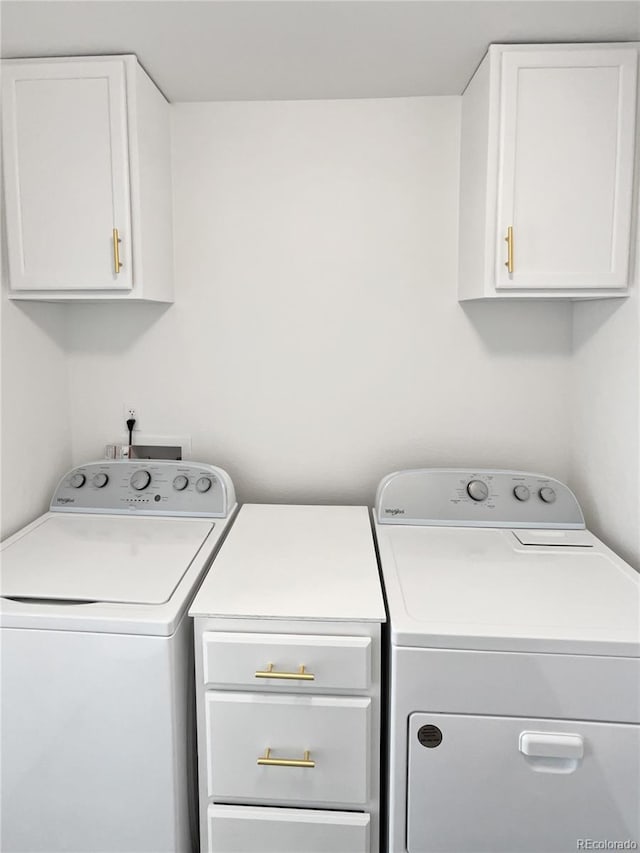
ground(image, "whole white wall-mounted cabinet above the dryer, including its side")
xmin=459 ymin=44 xmax=638 ymax=300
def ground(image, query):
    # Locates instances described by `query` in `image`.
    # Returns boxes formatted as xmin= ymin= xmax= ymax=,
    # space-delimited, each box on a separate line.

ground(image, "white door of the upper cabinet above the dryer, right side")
xmin=496 ymin=48 xmax=638 ymax=290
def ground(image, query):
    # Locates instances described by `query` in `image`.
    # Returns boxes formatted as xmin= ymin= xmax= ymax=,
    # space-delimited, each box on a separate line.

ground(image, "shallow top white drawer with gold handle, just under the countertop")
xmin=202 ymin=631 xmax=371 ymax=692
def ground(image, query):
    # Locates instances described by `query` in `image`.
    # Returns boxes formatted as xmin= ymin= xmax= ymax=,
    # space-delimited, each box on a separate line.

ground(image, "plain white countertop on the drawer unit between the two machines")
xmin=189 ymin=504 xmax=386 ymax=622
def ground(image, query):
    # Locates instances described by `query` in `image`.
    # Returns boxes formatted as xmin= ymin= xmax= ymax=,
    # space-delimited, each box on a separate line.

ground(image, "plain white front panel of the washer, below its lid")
xmin=0 ymin=619 xmax=192 ymax=853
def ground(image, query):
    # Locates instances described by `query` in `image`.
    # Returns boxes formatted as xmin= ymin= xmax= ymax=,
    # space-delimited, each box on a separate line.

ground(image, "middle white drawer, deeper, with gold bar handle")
xmin=205 ymin=691 xmax=371 ymax=806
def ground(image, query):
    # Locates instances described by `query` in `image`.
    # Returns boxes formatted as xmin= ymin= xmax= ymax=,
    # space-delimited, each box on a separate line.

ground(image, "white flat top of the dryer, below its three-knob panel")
xmin=376 ymin=525 xmax=640 ymax=656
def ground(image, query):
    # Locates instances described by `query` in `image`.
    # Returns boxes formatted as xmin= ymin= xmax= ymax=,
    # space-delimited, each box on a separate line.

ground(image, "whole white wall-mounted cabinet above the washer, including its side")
xmin=2 ymin=56 xmax=173 ymax=302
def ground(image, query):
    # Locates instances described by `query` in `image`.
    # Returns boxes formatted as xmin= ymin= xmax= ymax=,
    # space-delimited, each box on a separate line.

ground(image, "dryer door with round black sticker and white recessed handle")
xmin=407 ymin=708 xmax=640 ymax=853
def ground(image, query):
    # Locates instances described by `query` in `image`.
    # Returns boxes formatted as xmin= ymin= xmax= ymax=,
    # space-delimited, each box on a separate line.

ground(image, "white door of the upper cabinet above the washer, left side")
xmin=2 ymin=59 xmax=132 ymax=290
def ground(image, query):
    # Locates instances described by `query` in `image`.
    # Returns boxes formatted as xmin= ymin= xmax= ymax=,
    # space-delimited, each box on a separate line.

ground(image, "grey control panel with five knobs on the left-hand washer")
xmin=50 ymin=459 xmax=236 ymax=518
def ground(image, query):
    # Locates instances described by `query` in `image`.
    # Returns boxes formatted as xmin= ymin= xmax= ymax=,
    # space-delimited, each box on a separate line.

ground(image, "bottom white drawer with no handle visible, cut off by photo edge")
xmin=207 ymin=805 xmax=369 ymax=853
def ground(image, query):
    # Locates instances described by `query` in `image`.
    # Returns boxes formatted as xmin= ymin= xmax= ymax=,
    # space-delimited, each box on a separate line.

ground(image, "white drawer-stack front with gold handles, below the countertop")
xmin=194 ymin=620 xmax=381 ymax=853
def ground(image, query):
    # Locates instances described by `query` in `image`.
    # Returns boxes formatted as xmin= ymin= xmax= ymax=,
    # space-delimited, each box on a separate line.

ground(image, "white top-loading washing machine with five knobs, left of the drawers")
xmin=0 ymin=461 xmax=236 ymax=853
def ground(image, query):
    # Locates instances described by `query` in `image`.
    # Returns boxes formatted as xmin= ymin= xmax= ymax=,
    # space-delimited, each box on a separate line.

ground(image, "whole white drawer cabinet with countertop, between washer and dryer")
xmin=189 ymin=504 xmax=385 ymax=853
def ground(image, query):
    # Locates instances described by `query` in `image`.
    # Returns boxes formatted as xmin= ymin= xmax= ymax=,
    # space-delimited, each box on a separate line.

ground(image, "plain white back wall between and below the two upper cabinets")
xmin=69 ymin=97 xmax=571 ymax=503
